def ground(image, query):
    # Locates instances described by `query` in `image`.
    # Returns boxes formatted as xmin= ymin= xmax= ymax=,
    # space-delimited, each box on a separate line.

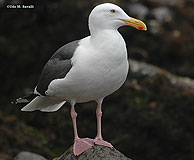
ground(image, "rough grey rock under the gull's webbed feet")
xmin=54 ymin=145 xmax=131 ymax=160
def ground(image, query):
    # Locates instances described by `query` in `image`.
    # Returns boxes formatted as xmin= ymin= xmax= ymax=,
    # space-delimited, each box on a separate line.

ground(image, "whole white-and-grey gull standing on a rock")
xmin=16 ymin=3 xmax=146 ymax=155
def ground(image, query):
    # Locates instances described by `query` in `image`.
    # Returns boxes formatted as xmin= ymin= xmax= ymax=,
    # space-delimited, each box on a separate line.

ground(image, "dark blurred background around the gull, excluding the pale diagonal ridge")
xmin=0 ymin=0 xmax=194 ymax=160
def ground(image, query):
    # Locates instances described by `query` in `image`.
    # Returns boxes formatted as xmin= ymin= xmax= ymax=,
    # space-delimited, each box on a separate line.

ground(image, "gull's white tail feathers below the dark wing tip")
xmin=21 ymin=96 xmax=65 ymax=112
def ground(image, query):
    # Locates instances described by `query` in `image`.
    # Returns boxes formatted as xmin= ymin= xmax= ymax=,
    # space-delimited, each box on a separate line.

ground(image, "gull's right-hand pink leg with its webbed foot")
xmin=94 ymin=100 xmax=113 ymax=148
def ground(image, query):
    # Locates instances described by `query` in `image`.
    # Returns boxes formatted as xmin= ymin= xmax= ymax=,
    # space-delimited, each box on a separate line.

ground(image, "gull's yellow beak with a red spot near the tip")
xmin=121 ymin=17 xmax=147 ymax=31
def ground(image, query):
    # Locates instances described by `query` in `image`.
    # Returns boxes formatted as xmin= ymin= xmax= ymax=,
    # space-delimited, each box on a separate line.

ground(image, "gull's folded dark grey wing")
xmin=36 ymin=40 xmax=79 ymax=96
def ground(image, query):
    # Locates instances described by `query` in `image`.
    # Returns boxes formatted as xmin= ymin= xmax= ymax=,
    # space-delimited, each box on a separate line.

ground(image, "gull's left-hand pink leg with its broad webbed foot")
xmin=71 ymin=105 xmax=94 ymax=156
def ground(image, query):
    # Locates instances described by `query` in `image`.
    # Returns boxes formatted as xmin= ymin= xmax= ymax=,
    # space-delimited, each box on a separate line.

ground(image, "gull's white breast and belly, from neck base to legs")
xmin=48 ymin=32 xmax=128 ymax=102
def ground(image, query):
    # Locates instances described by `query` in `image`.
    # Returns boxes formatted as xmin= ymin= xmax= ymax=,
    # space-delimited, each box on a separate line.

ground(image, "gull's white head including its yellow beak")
xmin=89 ymin=3 xmax=147 ymax=32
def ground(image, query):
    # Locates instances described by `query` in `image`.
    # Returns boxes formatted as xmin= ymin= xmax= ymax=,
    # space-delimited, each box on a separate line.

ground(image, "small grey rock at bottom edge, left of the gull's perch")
xmin=14 ymin=151 xmax=47 ymax=160
